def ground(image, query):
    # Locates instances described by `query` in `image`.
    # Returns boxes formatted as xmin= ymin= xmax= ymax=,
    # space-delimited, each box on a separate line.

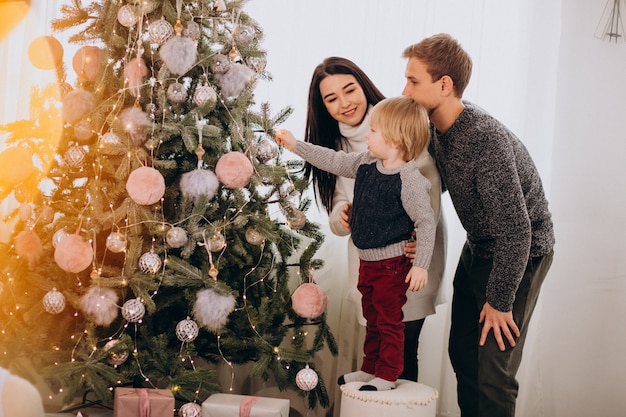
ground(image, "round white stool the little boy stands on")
xmin=340 ymin=379 xmax=439 ymax=417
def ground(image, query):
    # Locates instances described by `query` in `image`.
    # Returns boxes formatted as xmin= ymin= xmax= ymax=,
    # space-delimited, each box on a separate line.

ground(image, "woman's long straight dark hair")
xmin=304 ymin=57 xmax=385 ymax=213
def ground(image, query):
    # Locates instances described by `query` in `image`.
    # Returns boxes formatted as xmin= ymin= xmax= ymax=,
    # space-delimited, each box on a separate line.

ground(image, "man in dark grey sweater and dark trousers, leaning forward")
xmin=403 ymin=34 xmax=554 ymax=417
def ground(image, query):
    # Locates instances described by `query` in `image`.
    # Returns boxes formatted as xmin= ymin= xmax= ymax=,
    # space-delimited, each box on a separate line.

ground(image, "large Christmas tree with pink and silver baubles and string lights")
xmin=0 ymin=0 xmax=336 ymax=408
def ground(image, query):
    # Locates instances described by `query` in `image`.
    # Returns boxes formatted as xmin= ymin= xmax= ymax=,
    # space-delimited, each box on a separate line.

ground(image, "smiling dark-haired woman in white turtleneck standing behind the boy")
xmin=304 ymin=57 xmax=445 ymax=382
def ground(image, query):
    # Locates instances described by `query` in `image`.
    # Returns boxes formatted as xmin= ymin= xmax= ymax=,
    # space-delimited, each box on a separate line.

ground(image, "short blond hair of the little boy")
xmin=370 ymin=96 xmax=430 ymax=161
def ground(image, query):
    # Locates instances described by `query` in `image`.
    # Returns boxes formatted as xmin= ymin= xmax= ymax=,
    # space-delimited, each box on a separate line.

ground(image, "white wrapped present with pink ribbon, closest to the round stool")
xmin=202 ymin=394 xmax=289 ymax=417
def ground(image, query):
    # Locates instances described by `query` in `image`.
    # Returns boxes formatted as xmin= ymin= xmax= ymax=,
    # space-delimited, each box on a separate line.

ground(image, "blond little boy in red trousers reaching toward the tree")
xmin=276 ymin=97 xmax=436 ymax=391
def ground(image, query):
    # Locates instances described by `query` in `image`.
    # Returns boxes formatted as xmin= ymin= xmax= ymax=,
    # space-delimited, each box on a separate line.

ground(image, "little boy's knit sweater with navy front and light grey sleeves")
xmin=294 ymin=142 xmax=436 ymax=269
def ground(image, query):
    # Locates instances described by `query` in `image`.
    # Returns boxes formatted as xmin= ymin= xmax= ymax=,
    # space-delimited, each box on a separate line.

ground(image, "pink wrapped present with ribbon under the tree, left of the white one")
xmin=113 ymin=387 xmax=175 ymax=417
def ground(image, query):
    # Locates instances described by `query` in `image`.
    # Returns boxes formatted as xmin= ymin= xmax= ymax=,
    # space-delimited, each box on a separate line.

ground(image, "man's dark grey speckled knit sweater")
xmin=431 ymin=103 xmax=554 ymax=311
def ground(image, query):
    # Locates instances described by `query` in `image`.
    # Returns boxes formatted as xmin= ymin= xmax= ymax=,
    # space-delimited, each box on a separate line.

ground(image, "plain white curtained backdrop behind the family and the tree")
xmin=0 ymin=0 xmax=626 ymax=417
